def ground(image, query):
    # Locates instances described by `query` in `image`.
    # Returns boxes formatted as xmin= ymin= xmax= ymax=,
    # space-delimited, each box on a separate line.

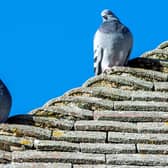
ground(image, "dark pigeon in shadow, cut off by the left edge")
xmin=0 ymin=80 xmax=12 ymax=123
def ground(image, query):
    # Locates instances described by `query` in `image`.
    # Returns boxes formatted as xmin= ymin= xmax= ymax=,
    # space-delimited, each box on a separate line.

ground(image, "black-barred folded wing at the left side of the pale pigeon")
xmin=94 ymin=48 xmax=104 ymax=75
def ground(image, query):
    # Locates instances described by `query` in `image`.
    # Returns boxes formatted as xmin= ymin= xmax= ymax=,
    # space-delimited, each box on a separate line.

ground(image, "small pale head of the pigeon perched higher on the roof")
xmin=101 ymin=9 xmax=119 ymax=22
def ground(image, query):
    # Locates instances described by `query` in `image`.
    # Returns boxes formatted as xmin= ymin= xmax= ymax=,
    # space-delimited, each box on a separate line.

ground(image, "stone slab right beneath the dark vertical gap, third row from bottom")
xmin=80 ymin=143 xmax=136 ymax=154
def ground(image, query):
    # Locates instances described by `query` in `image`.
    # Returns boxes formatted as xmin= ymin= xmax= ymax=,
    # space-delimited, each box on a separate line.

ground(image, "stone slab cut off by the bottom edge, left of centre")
xmin=10 ymin=162 xmax=72 ymax=168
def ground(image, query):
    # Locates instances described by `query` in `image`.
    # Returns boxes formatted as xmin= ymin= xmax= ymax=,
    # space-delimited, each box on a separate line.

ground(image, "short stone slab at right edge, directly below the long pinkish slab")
xmin=137 ymin=122 xmax=168 ymax=133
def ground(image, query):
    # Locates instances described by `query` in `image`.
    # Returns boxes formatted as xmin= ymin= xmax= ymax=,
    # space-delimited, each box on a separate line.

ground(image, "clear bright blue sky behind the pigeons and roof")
xmin=0 ymin=0 xmax=168 ymax=115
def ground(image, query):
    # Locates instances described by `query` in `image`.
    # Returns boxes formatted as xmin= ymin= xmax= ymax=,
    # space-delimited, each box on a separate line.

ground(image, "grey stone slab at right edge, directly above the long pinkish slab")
xmin=114 ymin=101 xmax=168 ymax=111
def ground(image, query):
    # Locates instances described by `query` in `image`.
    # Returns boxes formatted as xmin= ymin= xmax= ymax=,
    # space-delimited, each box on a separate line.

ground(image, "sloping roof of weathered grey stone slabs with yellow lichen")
xmin=0 ymin=42 xmax=168 ymax=168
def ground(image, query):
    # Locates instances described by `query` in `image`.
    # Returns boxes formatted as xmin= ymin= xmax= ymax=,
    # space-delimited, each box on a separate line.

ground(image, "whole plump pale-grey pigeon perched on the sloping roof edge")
xmin=94 ymin=9 xmax=133 ymax=75
